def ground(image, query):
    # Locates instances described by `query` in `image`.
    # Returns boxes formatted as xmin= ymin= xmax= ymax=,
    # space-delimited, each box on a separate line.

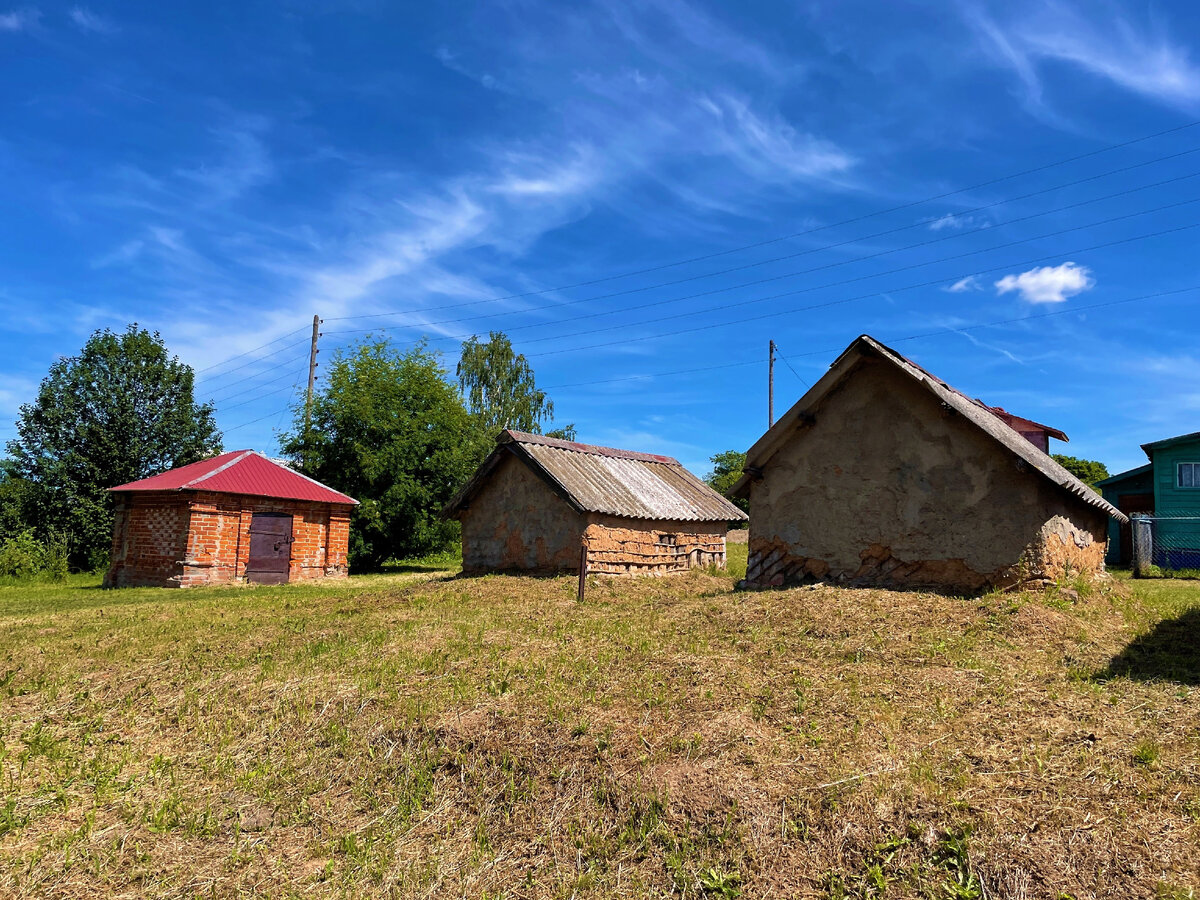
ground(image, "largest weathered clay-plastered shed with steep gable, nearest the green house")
xmin=731 ymin=335 xmax=1126 ymax=590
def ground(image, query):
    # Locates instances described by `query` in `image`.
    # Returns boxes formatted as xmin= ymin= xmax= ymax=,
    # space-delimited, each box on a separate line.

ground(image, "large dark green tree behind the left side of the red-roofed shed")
xmin=8 ymin=324 xmax=221 ymax=566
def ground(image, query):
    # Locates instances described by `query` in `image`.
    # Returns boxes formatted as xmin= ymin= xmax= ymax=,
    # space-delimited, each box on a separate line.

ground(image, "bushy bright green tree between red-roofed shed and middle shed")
xmin=283 ymin=337 xmax=481 ymax=571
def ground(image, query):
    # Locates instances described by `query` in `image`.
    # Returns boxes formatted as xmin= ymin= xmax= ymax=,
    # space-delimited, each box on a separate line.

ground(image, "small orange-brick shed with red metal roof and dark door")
xmin=104 ymin=450 xmax=356 ymax=588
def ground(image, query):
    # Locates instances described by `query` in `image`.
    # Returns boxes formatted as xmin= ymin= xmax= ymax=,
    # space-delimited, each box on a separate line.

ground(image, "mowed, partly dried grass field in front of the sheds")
xmin=0 ymin=556 xmax=1200 ymax=899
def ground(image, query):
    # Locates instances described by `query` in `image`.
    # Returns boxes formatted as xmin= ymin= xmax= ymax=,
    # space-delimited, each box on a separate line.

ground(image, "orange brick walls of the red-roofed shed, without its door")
xmin=104 ymin=491 xmax=350 ymax=587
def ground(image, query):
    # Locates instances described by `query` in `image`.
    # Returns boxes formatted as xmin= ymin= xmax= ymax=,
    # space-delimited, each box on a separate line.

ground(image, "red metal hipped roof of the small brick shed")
xmin=109 ymin=450 xmax=358 ymax=504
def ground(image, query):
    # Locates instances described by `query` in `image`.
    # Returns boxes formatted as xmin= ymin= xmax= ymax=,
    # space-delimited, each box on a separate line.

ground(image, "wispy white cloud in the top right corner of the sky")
xmin=960 ymin=2 xmax=1200 ymax=107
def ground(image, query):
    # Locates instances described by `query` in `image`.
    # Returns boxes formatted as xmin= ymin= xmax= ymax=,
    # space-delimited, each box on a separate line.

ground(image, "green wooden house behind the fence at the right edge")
xmin=1096 ymin=432 xmax=1200 ymax=569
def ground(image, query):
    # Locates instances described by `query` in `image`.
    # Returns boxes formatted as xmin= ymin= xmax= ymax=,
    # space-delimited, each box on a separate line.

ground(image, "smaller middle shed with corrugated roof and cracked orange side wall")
xmin=446 ymin=431 xmax=745 ymax=575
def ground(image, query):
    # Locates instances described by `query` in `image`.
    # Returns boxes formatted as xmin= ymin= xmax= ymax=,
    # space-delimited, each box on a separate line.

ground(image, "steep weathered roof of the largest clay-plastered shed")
xmin=730 ymin=335 xmax=1128 ymax=522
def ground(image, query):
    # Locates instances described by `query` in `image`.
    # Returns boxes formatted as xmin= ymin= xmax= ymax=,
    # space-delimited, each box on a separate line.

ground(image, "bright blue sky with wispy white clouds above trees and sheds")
xmin=0 ymin=0 xmax=1200 ymax=480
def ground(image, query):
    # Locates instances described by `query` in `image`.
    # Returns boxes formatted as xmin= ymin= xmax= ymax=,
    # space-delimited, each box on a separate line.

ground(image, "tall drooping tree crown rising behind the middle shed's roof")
xmin=457 ymin=331 xmax=575 ymax=440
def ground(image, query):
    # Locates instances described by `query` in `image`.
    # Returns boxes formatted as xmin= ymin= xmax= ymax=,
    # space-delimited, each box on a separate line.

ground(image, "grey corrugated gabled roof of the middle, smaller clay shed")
xmin=445 ymin=431 xmax=746 ymax=522
